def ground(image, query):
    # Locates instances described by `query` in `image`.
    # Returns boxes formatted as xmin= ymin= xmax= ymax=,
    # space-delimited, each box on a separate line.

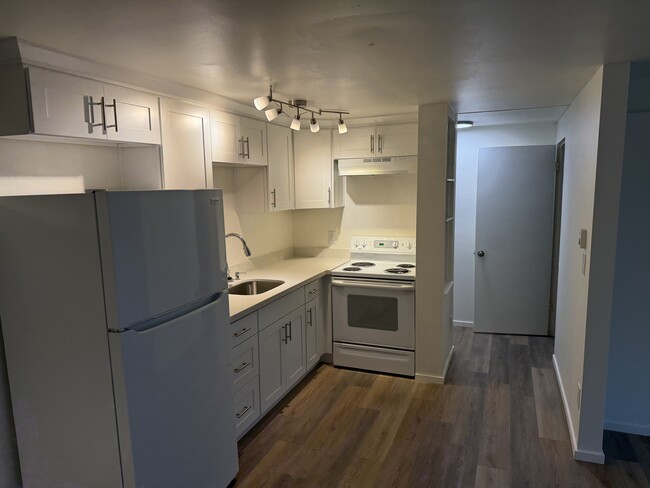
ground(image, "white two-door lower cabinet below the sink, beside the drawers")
xmin=259 ymin=306 xmax=307 ymax=413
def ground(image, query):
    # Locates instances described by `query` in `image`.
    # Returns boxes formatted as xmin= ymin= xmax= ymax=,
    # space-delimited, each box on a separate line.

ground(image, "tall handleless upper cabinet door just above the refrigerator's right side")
xmin=160 ymin=98 xmax=212 ymax=190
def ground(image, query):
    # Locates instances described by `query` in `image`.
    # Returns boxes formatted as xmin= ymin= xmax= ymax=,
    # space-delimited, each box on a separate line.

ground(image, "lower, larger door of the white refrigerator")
xmin=109 ymin=293 xmax=238 ymax=488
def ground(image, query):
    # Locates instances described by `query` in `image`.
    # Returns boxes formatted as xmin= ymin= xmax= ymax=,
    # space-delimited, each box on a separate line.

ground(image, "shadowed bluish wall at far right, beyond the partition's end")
xmin=605 ymin=111 xmax=650 ymax=436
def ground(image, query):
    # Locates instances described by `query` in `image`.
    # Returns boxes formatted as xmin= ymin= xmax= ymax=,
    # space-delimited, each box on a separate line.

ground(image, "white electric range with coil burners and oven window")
xmin=331 ymin=236 xmax=415 ymax=376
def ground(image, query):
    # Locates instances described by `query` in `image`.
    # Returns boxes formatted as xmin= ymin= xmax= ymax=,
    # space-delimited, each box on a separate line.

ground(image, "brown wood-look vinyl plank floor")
xmin=234 ymin=328 xmax=650 ymax=488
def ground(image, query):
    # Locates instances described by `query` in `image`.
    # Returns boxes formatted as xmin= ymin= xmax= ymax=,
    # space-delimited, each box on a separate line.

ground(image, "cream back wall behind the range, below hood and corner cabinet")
xmin=293 ymin=175 xmax=417 ymax=256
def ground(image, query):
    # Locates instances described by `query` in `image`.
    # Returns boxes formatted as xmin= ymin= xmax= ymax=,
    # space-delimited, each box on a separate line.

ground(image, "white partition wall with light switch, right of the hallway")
xmin=554 ymin=64 xmax=629 ymax=462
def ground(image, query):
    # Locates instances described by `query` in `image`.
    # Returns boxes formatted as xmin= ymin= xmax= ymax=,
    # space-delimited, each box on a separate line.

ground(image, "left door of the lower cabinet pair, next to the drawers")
xmin=259 ymin=319 xmax=287 ymax=413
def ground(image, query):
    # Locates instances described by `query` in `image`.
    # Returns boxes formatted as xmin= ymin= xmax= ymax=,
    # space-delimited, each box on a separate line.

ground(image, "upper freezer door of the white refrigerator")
xmin=95 ymin=190 xmax=228 ymax=330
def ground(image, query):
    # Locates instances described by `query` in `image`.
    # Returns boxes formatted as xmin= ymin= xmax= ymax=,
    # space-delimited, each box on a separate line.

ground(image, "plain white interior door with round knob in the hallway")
xmin=474 ymin=146 xmax=555 ymax=335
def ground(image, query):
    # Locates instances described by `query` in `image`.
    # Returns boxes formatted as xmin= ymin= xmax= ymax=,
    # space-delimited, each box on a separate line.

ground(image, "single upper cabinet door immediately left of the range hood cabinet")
xmin=293 ymin=129 xmax=333 ymax=209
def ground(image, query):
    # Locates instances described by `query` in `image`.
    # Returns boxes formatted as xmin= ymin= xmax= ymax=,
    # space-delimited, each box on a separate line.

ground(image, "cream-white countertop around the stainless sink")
xmin=228 ymin=258 xmax=348 ymax=321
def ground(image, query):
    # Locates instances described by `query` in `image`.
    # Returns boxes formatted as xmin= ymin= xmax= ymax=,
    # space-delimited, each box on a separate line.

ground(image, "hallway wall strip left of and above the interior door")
xmin=454 ymin=122 xmax=557 ymax=326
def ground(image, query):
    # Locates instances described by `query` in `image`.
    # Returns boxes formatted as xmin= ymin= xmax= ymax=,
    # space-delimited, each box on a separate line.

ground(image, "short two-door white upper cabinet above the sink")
xmin=210 ymin=110 xmax=268 ymax=166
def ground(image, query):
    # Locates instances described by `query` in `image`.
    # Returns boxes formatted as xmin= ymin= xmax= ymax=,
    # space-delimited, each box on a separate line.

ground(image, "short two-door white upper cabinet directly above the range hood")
xmin=334 ymin=123 xmax=418 ymax=159
